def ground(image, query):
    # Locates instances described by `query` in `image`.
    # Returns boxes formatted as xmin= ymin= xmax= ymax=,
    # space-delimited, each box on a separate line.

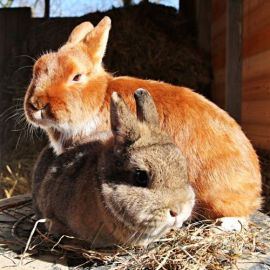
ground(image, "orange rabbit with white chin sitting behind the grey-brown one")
xmin=24 ymin=17 xmax=262 ymax=218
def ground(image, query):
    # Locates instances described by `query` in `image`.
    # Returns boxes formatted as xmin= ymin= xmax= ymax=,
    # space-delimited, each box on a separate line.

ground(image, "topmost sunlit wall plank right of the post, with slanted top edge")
xmin=242 ymin=50 xmax=270 ymax=81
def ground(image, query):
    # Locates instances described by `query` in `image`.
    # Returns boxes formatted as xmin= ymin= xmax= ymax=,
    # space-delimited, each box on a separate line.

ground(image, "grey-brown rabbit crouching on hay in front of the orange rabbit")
xmin=33 ymin=89 xmax=194 ymax=247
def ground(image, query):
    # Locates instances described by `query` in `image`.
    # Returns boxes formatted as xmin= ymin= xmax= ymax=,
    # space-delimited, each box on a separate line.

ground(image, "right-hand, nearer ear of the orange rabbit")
xmin=83 ymin=17 xmax=111 ymax=64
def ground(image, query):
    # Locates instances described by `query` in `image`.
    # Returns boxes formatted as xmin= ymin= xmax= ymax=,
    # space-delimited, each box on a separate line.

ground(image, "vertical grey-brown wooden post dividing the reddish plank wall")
xmin=225 ymin=0 xmax=243 ymax=123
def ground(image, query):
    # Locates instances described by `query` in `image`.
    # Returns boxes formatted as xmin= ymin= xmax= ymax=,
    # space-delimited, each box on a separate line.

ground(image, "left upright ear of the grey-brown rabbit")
xmin=111 ymin=92 xmax=140 ymax=145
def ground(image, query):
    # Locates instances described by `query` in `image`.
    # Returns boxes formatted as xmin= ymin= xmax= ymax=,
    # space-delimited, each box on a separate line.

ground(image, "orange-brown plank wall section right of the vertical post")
xmin=242 ymin=0 xmax=270 ymax=150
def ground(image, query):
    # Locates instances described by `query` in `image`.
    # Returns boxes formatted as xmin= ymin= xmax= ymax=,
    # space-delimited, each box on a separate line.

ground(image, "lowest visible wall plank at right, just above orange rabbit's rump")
xmin=242 ymin=122 xmax=270 ymax=150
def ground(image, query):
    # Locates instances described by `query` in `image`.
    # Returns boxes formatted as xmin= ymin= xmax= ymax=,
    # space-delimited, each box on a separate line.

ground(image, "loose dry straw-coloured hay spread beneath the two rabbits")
xmin=17 ymin=214 xmax=270 ymax=270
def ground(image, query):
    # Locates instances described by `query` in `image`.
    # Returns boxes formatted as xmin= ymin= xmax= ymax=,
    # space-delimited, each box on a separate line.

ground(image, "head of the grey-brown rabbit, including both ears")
xmin=96 ymin=89 xmax=194 ymax=244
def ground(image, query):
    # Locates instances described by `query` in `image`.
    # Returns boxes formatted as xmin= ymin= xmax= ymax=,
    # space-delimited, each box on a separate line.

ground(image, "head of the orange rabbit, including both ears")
xmin=24 ymin=17 xmax=111 ymax=153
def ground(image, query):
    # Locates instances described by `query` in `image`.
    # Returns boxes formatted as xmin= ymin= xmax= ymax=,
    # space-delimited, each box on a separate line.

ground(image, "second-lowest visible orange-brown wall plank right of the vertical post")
xmin=242 ymin=100 xmax=270 ymax=124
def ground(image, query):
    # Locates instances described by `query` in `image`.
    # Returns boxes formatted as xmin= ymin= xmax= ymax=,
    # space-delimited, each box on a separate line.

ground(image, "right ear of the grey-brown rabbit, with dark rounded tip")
xmin=134 ymin=88 xmax=159 ymax=126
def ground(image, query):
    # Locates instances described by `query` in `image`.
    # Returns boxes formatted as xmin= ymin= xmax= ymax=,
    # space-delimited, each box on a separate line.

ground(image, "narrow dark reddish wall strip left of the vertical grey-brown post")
xmin=210 ymin=0 xmax=227 ymax=108
